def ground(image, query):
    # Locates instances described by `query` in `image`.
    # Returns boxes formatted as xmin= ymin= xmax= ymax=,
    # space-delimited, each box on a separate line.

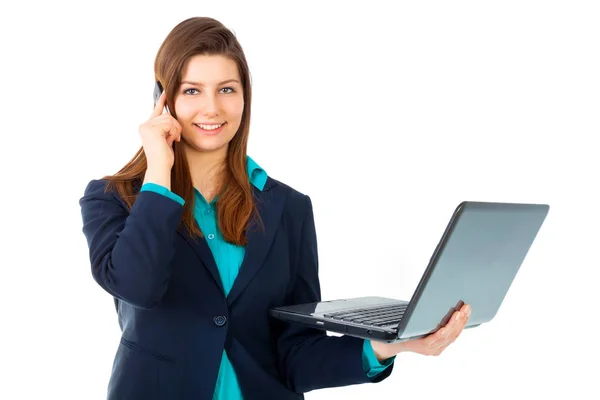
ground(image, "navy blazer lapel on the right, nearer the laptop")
xmin=227 ymin=178 xmax=285 ymax=306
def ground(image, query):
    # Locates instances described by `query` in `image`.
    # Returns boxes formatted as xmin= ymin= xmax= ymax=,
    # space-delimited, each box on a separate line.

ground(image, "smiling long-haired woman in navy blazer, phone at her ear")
xmin=80 ymin=18 xmax=468 ymax=400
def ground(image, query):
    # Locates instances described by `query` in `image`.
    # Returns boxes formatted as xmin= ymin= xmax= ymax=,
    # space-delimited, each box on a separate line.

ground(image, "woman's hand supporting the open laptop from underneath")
xmin=371 ymin=304 xmax=471 ymax=362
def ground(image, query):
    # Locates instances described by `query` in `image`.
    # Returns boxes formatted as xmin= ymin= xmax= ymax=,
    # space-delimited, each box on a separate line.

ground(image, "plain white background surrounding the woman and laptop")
xmin=0 ymin=0 xmax=600 ymax=400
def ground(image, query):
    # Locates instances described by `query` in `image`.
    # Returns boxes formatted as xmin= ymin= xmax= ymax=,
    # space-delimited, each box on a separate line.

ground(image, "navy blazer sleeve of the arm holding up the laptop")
xmin=278 ymin=196 xmax=393 ymax=393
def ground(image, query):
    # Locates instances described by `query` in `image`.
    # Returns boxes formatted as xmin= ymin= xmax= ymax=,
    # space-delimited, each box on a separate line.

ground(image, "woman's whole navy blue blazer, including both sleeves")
xmin=80 ymin=177 xmax=393 ymax=400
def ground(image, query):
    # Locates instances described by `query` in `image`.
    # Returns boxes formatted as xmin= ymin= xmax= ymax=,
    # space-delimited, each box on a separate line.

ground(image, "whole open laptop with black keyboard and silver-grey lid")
xmin=270 ymin=201 xmax=550 ymax=343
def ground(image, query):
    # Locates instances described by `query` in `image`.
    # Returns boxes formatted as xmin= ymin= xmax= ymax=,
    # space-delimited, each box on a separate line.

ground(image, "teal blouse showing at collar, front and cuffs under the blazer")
xmin=141 ymin=157 xmax=394 ymax=400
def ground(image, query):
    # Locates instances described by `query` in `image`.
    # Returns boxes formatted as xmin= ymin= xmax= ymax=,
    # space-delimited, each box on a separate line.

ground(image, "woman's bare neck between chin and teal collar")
xmin=182 ymin=142 xmax=227 ymax=202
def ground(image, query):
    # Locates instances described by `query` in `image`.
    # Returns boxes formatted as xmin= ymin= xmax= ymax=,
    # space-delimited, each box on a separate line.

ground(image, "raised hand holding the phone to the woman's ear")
xmin=139 ymin=92 xmax=181 ymax=171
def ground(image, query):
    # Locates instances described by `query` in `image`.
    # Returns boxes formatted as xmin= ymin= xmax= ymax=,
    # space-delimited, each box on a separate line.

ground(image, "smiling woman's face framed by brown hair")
xmin=175 ymin=55 xmax=244 ymax=154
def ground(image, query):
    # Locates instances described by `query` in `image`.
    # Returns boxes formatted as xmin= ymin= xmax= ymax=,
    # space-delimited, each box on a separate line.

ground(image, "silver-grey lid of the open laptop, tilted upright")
xmin=398 ymin=201 xmax=550 ymax=338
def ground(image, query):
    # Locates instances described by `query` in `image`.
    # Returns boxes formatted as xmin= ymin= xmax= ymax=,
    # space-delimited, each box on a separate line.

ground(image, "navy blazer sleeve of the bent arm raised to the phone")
xmin=79 ymin=180 xmax=183 ymax=309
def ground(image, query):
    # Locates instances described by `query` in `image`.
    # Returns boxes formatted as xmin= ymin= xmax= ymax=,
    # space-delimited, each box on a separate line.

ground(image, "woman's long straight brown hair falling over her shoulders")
xmin=103 ymin=17 xmax=259 ymax=246
